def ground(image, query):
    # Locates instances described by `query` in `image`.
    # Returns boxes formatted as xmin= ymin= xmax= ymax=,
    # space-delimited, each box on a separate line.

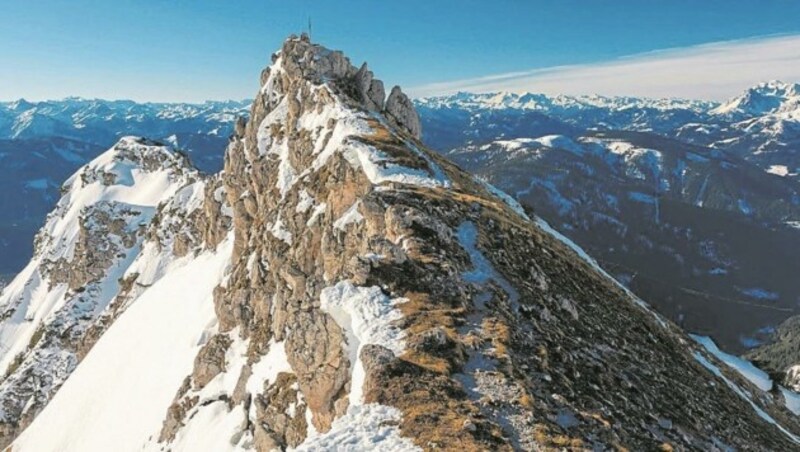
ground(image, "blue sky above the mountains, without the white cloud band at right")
xmin=0 ymin=0 xmax=800 ymax=101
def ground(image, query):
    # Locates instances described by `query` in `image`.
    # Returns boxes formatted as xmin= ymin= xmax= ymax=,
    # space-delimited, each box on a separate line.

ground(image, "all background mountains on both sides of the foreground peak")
xmin=0 ymin=82 xmax=800 ymax=350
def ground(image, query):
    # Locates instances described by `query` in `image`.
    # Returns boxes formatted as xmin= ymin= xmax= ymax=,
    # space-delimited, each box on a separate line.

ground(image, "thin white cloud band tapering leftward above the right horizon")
xmin=408 ymin=35 xmax=800 ymax=100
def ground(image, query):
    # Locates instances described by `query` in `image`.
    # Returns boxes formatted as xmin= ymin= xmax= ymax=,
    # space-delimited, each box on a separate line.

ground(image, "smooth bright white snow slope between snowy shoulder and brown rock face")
xmin=13 ymin=238 xmax=233 ymax=452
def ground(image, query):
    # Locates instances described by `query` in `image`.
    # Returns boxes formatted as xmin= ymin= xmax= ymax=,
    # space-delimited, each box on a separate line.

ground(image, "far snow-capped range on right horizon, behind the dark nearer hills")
xmin=417 ymin=81 xmax=800 ymax=182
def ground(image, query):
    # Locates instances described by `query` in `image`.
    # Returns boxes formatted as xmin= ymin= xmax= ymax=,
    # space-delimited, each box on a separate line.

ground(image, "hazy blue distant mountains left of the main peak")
xmin=0 ymin=98 xmax=250 ymax=279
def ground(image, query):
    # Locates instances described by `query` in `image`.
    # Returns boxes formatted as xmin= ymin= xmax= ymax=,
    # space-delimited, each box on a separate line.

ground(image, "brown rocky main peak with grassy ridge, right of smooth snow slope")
xmin=153 ymin=36 xmax=798 ymax=450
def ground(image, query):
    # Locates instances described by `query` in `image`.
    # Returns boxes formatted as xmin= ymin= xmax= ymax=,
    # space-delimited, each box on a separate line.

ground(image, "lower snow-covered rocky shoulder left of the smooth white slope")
xmin=0 ymin=137 xmax=202 ymax=446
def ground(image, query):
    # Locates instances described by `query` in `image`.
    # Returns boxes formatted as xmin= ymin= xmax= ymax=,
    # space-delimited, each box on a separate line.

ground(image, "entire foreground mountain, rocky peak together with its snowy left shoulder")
xmin=0 ymin=36 xmax=800 ymax=452
